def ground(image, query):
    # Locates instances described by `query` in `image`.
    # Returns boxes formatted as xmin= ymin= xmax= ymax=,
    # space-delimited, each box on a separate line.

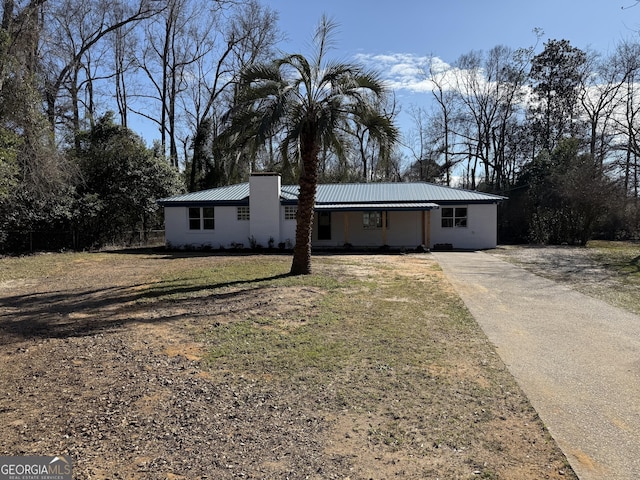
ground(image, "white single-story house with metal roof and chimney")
xmin=158 ymin=173 xmax=505 ymax=250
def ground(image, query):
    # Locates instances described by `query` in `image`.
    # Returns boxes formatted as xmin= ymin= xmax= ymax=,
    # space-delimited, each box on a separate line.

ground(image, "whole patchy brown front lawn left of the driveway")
xmin=0 ymin=252 xmax=575 ymax=480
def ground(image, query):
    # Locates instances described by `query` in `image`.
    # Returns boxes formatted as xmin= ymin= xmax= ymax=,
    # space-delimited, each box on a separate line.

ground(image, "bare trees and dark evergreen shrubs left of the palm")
xmin=0 ymin=0 xmax=279 ymax=250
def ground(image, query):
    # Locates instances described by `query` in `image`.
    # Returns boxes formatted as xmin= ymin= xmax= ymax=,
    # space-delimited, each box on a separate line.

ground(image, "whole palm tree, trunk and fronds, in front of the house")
xmin=231 ymin=16 xmax=398 ymax=275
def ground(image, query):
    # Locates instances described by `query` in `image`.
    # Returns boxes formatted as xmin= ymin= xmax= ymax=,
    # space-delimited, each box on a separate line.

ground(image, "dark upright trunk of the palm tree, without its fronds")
xmin=290 ymin=125 xmax=319 ymax=275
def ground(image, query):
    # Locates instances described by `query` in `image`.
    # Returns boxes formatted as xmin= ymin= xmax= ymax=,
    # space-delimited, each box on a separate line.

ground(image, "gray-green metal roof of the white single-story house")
xmin=158 ymin=182 xmax=505 ymax=209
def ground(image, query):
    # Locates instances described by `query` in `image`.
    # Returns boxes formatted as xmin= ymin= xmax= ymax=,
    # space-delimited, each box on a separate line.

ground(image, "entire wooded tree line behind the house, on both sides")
xmin=0 ymin=0 xmax=640 ymax=253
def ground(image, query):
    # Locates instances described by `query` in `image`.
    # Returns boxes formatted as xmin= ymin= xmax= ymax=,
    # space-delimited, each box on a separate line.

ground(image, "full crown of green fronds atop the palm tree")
xmin=226 ymin=17 xmax=399 ymax=184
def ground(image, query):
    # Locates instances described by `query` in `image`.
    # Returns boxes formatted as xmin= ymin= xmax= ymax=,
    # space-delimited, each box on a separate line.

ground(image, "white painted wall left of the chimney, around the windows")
xmin=164 ymin=207 xmax=250 ymax=248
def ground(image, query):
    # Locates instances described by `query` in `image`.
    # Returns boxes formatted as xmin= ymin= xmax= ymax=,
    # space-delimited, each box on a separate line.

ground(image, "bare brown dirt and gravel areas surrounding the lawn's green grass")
xmin=0 ymin=256 xmax=574 ymax=480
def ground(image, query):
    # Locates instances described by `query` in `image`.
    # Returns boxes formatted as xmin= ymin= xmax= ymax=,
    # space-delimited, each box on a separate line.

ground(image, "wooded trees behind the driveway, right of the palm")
xmin=405 ymin=36 xmax=640 ymax=243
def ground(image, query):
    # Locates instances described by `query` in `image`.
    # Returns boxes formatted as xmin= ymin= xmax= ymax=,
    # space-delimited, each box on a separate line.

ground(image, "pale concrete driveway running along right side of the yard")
xmin=433 ymin=252 xmax=640 ymax=480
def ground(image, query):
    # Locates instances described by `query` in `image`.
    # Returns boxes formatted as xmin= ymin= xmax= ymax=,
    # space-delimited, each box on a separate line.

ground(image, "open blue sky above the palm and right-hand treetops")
xmin=263 ymin=0 xmax=640 ymax=150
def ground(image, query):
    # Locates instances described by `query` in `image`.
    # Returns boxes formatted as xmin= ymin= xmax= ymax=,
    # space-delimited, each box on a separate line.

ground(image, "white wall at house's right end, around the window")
xmin=431 ymin=204 xmax=498 ymax=250
